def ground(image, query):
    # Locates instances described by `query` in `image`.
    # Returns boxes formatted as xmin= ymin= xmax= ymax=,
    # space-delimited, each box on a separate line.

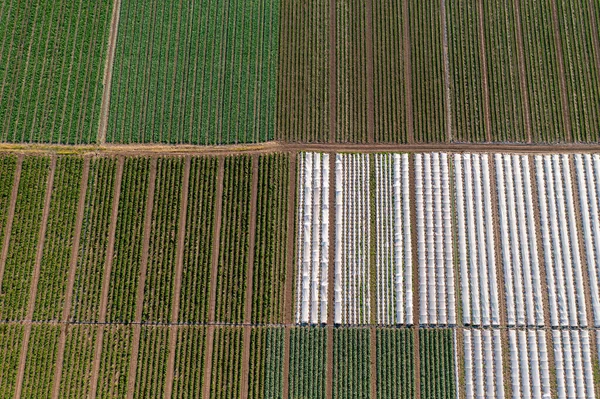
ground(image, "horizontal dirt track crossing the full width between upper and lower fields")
xmin=5 ymin=141 xmax=600 ymax=157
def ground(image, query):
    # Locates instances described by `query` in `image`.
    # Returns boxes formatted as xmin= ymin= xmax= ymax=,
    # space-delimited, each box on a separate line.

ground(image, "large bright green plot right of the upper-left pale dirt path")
xmin=106 ymin=0 xmax=280 ymax=144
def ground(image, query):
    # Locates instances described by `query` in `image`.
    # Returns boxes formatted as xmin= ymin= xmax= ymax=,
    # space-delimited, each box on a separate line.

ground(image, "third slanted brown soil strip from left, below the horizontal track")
xmin=52 ymin=157 xmax=90 ymax=399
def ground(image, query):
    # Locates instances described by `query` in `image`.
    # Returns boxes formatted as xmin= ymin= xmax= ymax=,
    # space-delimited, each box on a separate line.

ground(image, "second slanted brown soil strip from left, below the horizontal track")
xmin=15 ymin=157 xmax=56 ymax=398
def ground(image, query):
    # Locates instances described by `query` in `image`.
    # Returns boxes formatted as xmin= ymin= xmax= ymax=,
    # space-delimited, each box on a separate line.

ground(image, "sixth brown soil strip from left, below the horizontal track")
xmin=164 ymin=157 xmax=191 ymax=398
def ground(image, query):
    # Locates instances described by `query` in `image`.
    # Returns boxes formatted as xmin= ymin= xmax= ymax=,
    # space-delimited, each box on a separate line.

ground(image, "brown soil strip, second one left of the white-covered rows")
xmin=241 ymin=155 xmax=259 ymax=399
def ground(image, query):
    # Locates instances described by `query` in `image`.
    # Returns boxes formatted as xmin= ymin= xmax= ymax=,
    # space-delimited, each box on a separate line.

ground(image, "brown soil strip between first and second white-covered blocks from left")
xmin=325 ymin=152 xmax=336 ymax=399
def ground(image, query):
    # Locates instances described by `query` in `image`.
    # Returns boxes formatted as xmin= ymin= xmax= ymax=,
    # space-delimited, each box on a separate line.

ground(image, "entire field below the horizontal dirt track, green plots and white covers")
xmin=0 ymin=152 xmax=600 ymax=398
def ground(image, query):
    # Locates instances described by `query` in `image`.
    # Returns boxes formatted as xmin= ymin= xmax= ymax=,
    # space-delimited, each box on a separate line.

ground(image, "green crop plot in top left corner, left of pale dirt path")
xmin=0 ymin=0 xmax=113 ymax=144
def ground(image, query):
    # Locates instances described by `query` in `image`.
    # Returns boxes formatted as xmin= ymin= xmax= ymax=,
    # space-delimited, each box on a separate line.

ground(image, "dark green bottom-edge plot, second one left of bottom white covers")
xmin=375 ymin=328 xmax=415 ymax=399
